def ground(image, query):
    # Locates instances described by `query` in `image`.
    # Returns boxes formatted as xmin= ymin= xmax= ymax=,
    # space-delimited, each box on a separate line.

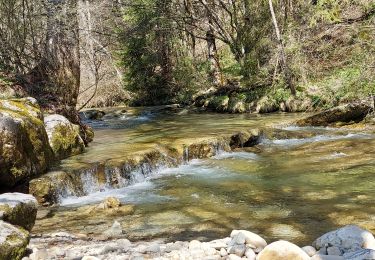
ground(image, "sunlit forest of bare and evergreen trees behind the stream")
xmin=0 ymin=0 xmax=375 ymax=113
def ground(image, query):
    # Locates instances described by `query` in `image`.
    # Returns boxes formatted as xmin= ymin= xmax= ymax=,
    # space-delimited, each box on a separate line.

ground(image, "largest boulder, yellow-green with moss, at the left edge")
xmin=0 ymin=98 xmax=54 ymax=187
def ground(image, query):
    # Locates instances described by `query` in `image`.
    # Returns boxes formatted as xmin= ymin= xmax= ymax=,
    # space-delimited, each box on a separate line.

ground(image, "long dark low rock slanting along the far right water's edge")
xmin=296 ymin=101 xmax=373 ymax=126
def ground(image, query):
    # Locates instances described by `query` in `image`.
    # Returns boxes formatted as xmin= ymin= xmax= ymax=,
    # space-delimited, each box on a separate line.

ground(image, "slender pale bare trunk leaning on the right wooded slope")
xmin=268 ymin=0 xmax=296 ymax=95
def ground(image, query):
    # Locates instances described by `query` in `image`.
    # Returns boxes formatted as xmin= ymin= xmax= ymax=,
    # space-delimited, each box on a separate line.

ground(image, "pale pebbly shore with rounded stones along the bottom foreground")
xmin=23 ymin=222 xmax=375 ymax=260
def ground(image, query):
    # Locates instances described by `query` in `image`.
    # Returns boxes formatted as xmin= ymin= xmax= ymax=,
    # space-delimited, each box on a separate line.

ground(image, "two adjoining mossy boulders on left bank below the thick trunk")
xmin=0 ymin=97 xmax=92 ymax=190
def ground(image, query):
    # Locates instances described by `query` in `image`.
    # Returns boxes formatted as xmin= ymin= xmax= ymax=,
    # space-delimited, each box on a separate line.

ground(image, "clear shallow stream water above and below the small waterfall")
xmin=34 ymin=107 xmax=375 ymax=245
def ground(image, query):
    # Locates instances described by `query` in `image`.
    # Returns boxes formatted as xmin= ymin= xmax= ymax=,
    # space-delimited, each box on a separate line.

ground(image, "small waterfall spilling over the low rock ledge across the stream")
xmin=34 ymin=129 xmax=264 ymax=202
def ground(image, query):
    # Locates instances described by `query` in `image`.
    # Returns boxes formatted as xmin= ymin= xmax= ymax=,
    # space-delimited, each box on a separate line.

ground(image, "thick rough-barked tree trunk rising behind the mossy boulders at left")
xmin=31 ymin=0 xmax=80 ymax=123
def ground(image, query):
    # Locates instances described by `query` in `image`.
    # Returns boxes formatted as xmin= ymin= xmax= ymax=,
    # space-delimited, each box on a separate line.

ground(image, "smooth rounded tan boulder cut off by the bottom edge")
xmin=257 ymin=240 xmax=310 ymax=260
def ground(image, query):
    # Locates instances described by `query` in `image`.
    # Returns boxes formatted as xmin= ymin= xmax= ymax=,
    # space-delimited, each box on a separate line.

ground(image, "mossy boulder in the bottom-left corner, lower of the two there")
xmin=0 ymin=220 xmax=30 ymax=260
